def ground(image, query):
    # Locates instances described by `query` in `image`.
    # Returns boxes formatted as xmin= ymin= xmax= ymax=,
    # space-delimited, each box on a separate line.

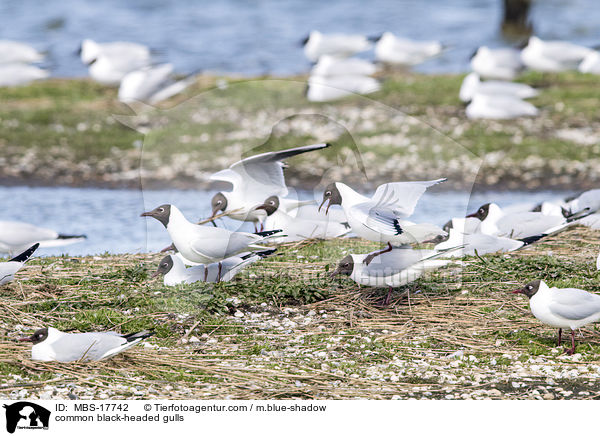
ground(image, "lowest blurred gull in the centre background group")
xmin=306 ymin=75 xmax=381 ymax=102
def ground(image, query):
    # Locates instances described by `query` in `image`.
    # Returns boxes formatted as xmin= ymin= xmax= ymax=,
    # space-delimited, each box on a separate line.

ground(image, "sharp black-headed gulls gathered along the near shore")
xmin=0 ymin=144 xmax=600 ymax=361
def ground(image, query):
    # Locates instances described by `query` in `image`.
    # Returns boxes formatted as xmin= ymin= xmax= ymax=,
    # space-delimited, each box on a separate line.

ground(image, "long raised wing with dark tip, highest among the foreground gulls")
xmin=210 ymin=144 xmax=329 ymax=198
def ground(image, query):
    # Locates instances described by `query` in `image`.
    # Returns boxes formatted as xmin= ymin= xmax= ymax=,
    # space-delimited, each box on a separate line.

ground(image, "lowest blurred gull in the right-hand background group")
xmin=465 ymin=92 xmax=539 ymax=120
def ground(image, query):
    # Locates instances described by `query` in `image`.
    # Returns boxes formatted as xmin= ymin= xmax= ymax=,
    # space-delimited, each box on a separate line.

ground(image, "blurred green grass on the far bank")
xmin=0 ymin=72 xmax=600 ymax=187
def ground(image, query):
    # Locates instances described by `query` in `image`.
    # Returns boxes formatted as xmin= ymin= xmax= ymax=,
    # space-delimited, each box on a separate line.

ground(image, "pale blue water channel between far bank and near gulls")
xmin=0 ymin=186 xmax=572 ymax=255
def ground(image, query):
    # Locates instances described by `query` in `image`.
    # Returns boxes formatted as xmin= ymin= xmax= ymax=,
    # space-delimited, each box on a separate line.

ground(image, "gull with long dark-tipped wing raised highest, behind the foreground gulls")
xmin=210 ymin=144 xmax=330 ymax=232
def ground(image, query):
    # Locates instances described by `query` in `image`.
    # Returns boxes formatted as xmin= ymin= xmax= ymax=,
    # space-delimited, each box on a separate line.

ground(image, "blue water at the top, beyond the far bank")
xmin=0 ymin=0 xmax=600 ymax=77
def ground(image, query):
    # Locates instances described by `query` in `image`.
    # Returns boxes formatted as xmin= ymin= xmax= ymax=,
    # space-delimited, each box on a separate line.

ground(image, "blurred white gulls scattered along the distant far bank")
xmin=0 ymin=30 xmax=600 ymax=115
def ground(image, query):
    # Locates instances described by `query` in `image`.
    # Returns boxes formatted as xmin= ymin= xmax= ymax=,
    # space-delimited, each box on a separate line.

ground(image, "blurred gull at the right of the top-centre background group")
xmin=375 ymin=32 xmax=443 ymax=65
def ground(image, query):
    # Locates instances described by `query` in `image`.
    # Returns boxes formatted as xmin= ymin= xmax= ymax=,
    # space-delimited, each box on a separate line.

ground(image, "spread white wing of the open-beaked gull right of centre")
xmin=371 ymin=179 xmax=446 ymax=217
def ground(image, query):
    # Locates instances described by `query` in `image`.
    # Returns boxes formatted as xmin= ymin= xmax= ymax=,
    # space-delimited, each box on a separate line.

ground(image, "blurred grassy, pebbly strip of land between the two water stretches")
xmin=0 ymin=72 xmax=600 ymax=191
